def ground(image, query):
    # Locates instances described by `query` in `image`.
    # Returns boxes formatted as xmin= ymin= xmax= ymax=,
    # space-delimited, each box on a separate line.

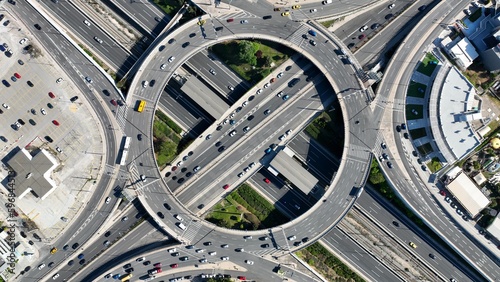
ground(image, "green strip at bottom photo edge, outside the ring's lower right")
xmin=296 ymin=242 xmax=365 ymax=282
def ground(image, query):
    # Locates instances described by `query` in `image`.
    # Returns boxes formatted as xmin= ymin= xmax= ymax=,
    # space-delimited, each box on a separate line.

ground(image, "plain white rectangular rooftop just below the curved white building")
xmin=446 ymin=173 xmax=490 ymax=218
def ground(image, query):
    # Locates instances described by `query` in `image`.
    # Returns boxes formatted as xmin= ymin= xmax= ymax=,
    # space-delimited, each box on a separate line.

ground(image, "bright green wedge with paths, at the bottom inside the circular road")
xmin=206 ymin=184 xmax=288 ymax=230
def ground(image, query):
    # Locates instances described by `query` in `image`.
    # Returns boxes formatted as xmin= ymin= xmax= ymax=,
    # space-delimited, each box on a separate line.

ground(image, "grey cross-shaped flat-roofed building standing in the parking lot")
xmin=7 ymin=148 xmax=59 ymax=200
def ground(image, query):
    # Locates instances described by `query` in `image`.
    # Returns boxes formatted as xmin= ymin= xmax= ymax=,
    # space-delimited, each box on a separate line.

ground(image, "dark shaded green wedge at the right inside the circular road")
xmin=305 ymin=107 xmax=344 ymax=156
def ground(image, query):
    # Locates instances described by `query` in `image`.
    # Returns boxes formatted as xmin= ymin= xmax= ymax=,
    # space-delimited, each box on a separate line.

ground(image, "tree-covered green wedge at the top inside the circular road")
xmin=210 ymin=40 xmax=295 ymax=83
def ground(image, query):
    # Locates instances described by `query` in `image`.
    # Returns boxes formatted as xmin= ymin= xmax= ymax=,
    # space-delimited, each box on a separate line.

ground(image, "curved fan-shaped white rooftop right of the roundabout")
xmin=438 ymin=67 xmax=480 ymax=159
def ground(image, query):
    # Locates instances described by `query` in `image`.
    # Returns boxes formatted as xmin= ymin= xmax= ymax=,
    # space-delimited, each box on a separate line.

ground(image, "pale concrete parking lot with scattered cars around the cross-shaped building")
xmin=0 ymin=11 xmax=103 ymax=242
